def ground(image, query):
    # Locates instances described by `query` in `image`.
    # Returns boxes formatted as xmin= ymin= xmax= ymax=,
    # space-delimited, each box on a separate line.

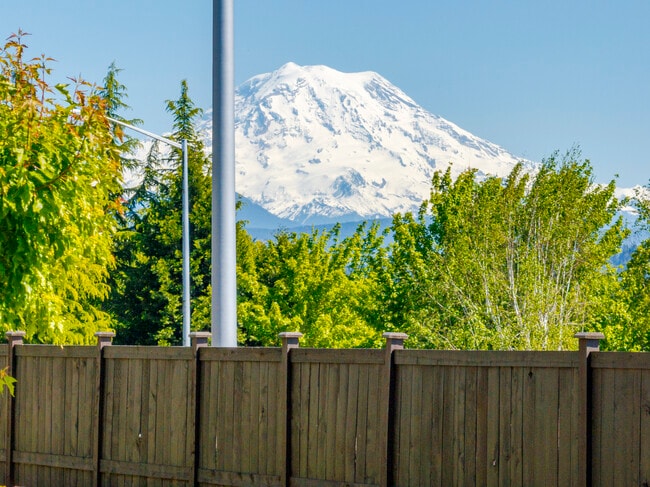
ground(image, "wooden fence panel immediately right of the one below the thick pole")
xmin=289 ymin=349 xmax=387 ymax=486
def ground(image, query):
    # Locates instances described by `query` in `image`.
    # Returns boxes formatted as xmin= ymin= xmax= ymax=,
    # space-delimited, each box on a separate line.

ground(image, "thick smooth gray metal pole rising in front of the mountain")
xmin=212 ymin=0 xmax=237 ymax=347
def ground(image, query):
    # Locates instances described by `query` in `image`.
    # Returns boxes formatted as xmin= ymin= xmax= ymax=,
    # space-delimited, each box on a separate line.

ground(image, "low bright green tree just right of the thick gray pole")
xmin=237 ymin=225 xmax=381 ymax=348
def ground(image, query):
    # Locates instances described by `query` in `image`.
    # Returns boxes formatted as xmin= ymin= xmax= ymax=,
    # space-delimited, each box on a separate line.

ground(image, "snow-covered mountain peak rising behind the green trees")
xmin=235 ymin=63 xmax=532 ymax=224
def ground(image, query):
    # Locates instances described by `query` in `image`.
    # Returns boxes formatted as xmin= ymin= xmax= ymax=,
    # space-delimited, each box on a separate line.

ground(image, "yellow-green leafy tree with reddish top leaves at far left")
xmin=0 ymin=32 xmax=120 ymax=343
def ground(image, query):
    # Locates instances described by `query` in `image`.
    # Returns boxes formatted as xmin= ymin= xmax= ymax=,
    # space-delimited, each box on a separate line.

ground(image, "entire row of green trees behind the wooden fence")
xmin=0 ymin=36 xmax=650 ymax=350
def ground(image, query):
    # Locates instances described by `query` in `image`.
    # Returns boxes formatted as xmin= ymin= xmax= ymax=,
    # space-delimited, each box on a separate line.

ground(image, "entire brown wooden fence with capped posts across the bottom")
xmin=0 ymin=332 xmax=650 ymax=487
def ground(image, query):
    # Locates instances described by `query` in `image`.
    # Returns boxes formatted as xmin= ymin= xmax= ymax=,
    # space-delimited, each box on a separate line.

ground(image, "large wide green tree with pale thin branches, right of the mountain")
xmin=384 ymin=151 xmax=625 ymax=349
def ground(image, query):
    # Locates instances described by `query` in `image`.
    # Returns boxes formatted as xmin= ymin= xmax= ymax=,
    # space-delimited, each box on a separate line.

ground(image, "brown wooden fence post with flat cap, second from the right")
xmin=379 ymin=332 xmax=408 ymax=487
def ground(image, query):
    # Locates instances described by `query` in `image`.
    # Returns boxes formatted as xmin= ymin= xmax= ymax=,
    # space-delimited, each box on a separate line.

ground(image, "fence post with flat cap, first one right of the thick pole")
xmin=278 ymin=331 xmax=302 ymax=487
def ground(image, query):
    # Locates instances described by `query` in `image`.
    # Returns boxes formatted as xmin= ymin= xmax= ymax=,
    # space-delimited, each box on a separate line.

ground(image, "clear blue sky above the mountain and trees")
xmin=0 ymin=0 xmax=650 ymax=187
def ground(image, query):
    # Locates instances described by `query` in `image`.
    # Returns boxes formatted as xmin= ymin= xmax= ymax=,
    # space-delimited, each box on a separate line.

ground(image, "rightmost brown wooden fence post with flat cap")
xmin=574 ymin=332 xmax=605 ymax=486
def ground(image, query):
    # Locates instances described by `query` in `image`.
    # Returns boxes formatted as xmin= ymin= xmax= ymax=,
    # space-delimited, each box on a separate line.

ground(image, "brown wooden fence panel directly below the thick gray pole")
xmin=198 ymin=348 xmax=286 ymax=486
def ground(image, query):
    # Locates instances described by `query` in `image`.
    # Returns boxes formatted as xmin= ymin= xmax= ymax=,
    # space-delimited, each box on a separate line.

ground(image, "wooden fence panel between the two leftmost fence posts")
xmin=13 ymin=346 xmax=98 ymax=485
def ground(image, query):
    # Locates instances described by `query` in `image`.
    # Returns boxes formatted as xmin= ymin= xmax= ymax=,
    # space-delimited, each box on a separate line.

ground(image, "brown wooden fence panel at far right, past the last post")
xmin=591 ymin=352 xmax=650 ymax=486
